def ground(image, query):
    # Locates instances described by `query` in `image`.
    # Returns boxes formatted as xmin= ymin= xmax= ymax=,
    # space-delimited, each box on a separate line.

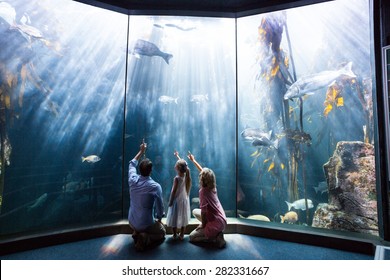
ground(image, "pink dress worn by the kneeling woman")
xmin=199 ymin=187 xmax=226 ymax=238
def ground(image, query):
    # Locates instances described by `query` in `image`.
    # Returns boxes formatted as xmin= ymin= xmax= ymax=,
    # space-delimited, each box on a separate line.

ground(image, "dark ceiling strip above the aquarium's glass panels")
xmin=76 ymin=0 xmax=324 ymax=17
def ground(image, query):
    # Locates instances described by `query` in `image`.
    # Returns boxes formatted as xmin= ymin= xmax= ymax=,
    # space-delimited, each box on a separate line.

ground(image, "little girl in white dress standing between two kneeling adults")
xmin=167 ymin=151 xmax=191 ymax=240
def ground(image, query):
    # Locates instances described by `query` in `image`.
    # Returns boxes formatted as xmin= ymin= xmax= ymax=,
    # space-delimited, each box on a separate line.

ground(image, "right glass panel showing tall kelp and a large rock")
xmin=237 ymin=0 xmax=378 ymax=235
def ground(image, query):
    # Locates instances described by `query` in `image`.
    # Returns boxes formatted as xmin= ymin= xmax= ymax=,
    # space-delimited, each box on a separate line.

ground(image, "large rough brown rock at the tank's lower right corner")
xmin=312 ymin=142 xmax=378 ymax=235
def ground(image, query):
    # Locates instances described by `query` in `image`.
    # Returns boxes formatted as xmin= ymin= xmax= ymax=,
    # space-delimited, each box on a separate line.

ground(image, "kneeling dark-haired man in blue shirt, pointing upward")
xmin=129 ymin=141 xmax=165 ymax=251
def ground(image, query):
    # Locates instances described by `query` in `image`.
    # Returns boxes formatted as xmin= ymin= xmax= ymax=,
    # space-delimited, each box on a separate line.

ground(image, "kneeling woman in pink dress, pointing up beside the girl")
xmin=188 ymin=152 xmax=226 ymax=248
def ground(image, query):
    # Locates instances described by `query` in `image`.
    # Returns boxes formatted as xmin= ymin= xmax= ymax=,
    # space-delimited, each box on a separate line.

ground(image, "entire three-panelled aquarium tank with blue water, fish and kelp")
xmin=0 ymin=0 xmax=378 ymax=239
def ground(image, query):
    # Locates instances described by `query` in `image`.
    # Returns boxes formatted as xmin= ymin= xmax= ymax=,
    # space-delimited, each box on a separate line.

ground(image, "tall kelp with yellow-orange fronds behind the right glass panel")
xmin=252 ymin=12 xmax=311 ymax=212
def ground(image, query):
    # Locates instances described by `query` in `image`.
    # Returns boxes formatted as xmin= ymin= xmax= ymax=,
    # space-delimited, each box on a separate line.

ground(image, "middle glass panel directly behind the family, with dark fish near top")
xmin=124 ymin=16 xmax=236 ymax=216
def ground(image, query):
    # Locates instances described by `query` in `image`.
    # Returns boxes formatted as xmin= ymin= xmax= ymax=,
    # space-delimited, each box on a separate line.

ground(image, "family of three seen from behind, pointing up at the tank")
xmin=128 ymin=141 xmax=226 ymax=251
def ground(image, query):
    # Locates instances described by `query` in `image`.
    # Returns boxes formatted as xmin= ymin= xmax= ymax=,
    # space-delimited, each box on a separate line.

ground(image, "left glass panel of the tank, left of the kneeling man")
xmin=0 ymin=0 xmax=128 ymax=236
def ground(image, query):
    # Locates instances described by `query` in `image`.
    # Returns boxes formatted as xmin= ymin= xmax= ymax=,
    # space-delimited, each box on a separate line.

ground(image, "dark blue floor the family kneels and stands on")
xmin=0 ymin=234 xmax=374 ymax=260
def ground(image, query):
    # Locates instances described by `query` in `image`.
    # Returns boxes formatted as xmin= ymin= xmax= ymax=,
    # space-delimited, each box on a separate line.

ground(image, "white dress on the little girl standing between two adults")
xmin=167 ymin=175 xmax=191 ymax=228
